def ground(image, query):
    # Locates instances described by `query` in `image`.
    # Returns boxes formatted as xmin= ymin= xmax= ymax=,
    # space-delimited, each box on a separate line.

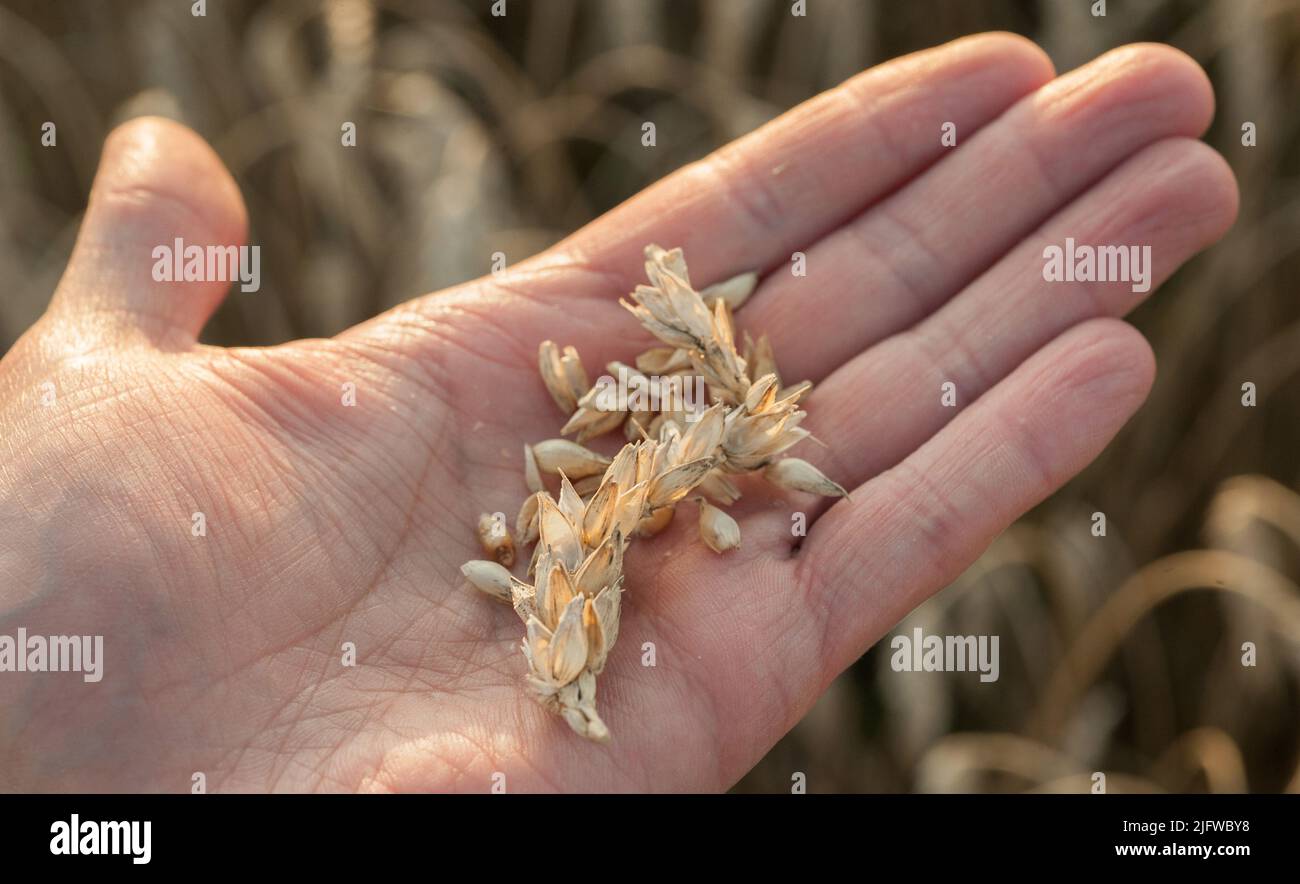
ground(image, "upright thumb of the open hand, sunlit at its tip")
xmin=49 ymin=117 xmax=247 ymax=347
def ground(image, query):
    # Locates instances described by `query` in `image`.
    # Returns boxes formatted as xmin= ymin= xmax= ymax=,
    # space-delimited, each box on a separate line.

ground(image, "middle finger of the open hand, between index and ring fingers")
xmin=737 ymin=44 xmax=1213 ymax=382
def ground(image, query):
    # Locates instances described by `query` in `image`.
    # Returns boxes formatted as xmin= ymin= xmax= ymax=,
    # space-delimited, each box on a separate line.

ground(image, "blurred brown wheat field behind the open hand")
xmin=0 ymin=0 xmax=1300 ymax=792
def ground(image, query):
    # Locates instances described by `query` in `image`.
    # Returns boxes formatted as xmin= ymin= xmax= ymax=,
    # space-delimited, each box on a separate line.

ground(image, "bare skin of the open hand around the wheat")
xmin=0 ymin=34 xmax=1238 ymax=792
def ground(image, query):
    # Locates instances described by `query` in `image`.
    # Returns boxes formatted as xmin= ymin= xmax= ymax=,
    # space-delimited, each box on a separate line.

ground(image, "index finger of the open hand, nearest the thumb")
xmin=555 ymin=33 xmax=1054 ymax=298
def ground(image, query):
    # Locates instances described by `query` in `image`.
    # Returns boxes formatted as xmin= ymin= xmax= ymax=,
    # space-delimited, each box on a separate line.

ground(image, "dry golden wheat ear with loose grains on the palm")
xmin=462 ymin=246 xmax=846 ymax=742
